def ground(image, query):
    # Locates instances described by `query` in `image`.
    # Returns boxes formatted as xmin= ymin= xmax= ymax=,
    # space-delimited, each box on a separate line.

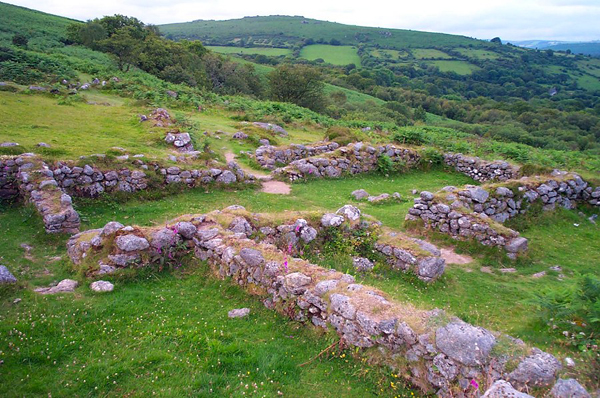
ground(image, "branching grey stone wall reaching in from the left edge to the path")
xmin=0 ymin=153 xmax=255 ymax=234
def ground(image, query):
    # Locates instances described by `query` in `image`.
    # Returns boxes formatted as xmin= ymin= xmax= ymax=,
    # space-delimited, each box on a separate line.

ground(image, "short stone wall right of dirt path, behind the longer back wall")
xmin=254 ymin=142 xmax=340 ymax=170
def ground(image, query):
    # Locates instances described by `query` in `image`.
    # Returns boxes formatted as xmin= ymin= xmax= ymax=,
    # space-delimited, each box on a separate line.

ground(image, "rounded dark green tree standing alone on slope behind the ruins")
xmin=268 ymin=65 xmax=325 ymax=111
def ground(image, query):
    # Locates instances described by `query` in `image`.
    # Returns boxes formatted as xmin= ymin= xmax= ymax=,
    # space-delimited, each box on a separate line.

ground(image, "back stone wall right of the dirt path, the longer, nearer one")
xmin=273 ymin=142 xmax=420 ymax=181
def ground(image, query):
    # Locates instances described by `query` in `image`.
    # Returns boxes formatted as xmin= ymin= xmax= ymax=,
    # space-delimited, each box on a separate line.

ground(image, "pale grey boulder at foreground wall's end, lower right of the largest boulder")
xmin=508 ymin=348 xmax=562 ymax=387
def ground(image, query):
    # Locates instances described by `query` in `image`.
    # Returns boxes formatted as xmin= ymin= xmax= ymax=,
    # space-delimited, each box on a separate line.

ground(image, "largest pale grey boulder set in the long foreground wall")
xmin=435 ymin=320 xmax=496 ymax=366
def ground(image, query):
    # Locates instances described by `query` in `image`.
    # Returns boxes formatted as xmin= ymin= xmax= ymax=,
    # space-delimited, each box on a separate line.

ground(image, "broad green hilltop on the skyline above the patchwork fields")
xmin=160 ymin=16 xmax=483 ymax=49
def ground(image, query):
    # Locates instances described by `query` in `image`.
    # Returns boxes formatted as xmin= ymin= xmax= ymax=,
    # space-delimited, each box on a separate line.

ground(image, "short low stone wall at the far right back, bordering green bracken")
xmin=444 ymin=153 xmax=519 ymax=182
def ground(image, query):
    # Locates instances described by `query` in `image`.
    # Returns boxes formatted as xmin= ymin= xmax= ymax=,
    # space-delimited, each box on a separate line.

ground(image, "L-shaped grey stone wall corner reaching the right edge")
xmin=406 ymin=171 xmax=600 ymax=258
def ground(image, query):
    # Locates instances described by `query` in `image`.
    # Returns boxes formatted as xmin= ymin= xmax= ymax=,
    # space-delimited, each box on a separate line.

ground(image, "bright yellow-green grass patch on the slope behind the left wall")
xmin=0 ymin=91 xmax=172 ymax=159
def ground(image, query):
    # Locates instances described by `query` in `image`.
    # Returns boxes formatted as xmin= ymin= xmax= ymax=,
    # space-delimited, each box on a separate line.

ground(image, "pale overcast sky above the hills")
xmin=3 ymin=0 xmax=600 ymax=41
